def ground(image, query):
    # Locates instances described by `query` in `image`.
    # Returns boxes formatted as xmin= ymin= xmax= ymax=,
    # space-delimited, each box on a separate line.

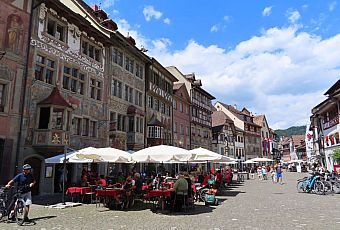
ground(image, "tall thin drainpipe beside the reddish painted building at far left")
xmin=14 ymin=0 xmax=44 ymax=175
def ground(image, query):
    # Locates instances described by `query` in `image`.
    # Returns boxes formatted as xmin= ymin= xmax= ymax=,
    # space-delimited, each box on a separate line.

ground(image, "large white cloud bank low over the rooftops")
xmin=150 ymin=26 xmax=340 ymax=128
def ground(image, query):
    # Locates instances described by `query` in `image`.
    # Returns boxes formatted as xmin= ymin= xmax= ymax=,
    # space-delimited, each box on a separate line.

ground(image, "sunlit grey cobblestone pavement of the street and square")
xmin=0 ymin=173 xmax=340 ymax=230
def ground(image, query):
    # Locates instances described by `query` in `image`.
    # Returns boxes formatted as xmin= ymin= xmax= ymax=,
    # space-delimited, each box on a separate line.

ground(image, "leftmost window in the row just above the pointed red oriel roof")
xmin=34 ymin=54 xmax=55 ymax=84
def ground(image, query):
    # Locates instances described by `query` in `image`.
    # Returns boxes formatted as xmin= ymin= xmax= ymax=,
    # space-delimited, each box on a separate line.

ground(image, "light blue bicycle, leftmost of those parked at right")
xmin=296 ymin=174 xmax=325 ymax=195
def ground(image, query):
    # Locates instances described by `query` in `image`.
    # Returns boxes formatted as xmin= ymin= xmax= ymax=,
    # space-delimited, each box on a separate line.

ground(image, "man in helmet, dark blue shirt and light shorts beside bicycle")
xmin=6 ymin=164 xmax=36 ymax=222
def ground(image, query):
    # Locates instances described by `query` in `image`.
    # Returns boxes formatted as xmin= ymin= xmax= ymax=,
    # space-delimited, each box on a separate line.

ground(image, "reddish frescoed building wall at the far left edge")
xmin=0 ymin=0 xmax=31 ymax=184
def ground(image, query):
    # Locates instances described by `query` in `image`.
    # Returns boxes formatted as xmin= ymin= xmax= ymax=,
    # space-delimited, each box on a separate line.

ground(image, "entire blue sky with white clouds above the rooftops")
xmin=86 ymin=0 xmax=340 ymax=129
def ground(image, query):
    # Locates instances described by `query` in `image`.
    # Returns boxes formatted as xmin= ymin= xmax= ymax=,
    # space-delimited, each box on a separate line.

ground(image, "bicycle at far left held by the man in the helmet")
xmin=0 ymin=186 xmax=26 ymax=226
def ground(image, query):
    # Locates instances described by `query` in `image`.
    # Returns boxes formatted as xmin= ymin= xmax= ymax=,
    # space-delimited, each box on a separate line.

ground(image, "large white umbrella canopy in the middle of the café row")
xmin=131 ymin=145 xmax=192 ymax=163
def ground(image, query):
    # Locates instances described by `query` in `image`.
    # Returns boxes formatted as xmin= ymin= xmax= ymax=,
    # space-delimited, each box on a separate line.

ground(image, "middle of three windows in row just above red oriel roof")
xmin=63 ymin=66 xmax=85 ymax=95
